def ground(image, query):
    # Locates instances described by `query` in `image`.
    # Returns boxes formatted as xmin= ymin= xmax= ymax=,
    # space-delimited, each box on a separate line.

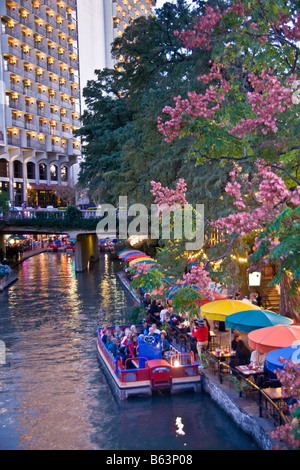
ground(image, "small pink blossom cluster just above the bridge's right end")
xmin=150 ymin=178 xmax=187 ymax=207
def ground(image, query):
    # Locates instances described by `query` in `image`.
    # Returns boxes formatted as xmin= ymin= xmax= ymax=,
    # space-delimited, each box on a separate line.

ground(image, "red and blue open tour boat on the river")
xmin=97 ymin=325 xmax=201 ymax=400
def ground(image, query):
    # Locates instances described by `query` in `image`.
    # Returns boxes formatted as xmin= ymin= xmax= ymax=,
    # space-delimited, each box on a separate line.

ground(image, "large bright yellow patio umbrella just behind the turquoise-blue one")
xmin=201 ymin=299 xmax=260 ymax=321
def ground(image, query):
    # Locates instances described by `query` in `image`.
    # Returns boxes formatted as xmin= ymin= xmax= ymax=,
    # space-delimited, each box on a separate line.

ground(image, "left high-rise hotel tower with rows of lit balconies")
xmin=0 ymin=0 xmax=81 ymax=207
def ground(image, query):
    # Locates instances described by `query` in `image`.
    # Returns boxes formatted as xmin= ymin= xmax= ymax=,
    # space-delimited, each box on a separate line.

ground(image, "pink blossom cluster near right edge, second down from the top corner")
xmin=229 ymin=70 xmax=292 ymax=138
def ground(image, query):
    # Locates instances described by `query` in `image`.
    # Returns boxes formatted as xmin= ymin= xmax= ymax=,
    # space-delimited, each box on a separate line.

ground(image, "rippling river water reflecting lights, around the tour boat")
xmin=0 ymin=253 xmax=257 ymax=451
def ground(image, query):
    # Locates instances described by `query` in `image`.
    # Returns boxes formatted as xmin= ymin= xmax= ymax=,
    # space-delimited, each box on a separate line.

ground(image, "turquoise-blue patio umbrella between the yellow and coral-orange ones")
xmin=225 ymin=304 xmax=293 ymax=333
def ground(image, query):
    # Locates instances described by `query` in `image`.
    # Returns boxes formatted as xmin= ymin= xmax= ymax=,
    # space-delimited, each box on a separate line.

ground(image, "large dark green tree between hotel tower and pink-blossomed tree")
xmin=78 ymin=1 xmax=213 ymax=203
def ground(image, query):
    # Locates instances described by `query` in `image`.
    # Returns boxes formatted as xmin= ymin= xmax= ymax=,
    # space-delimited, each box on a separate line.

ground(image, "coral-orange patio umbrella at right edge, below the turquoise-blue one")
xmin=248 ymin=325 xmax=300 ymax=354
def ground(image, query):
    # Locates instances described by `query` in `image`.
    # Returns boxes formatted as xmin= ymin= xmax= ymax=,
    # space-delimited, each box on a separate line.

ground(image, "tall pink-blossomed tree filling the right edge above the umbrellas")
xmin=158 ymin=0 xmax=300 ymax=320
